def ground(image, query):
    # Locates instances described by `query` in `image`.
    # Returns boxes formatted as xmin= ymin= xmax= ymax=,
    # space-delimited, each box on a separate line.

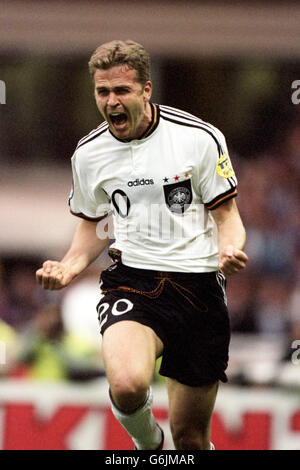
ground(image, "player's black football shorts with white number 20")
xmin=97 ymin=263 xmax=230 ymax=386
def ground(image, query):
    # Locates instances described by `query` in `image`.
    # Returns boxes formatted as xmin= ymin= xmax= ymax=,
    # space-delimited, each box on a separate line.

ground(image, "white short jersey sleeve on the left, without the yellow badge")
xmin=68 ymin=152 xmax=110 ymax=221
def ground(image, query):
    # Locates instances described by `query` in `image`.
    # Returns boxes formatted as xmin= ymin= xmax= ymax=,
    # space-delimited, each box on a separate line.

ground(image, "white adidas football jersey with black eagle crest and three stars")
xmin=69 ymin=104 xmax=237 ymax=272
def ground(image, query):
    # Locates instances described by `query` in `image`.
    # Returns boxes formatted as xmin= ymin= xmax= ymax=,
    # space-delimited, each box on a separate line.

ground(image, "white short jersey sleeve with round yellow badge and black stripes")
xmin=199 ymin=129 xmax=237 ymax=210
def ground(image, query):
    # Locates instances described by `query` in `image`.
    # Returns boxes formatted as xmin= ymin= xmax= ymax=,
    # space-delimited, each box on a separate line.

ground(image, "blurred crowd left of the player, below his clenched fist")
xmin=0 ymin=263 xmax=104 ymax=381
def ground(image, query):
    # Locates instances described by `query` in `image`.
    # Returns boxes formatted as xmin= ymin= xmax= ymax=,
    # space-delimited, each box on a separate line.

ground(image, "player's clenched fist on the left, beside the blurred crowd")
xmin=36 ymin=260 xmax=75 ymax=290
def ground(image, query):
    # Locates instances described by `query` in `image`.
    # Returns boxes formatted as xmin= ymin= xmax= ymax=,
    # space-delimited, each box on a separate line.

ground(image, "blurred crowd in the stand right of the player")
xmin=228 ymin=115 xmax=300 ymax=348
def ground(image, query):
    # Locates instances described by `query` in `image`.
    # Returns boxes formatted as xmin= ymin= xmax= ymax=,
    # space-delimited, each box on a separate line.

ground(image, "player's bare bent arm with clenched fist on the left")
xmin=36 ymin=219 xmax=109 ymax=290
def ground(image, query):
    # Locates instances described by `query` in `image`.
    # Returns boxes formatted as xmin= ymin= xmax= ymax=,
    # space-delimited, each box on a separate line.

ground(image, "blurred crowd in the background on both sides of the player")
xmin=0 ymin=113 xmax=300 ymax=381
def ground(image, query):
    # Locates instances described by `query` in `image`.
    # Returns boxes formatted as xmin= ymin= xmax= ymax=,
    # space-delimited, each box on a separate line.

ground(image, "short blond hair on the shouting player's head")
xmin=89 ymin=39 xmax=150 ymax=86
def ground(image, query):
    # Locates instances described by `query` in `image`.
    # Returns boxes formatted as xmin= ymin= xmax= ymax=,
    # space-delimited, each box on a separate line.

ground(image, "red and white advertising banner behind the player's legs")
xmin=0 ymin=382 xmax=300 ymax=450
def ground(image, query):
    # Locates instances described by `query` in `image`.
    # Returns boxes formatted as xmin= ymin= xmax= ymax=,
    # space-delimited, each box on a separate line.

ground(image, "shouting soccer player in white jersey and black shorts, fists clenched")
xmin=36 ymin=40 xmax=248 ymax=450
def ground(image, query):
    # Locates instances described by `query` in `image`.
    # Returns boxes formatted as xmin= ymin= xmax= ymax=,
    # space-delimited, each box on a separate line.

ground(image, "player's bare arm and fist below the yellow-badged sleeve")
xmin=211 ymin=199 xmax=248 ymax=275
